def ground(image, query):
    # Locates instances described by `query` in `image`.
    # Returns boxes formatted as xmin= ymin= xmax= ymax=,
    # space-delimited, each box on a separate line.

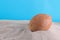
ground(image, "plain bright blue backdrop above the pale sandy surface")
xmin=0 ymin=0 xmax=60 ymax=22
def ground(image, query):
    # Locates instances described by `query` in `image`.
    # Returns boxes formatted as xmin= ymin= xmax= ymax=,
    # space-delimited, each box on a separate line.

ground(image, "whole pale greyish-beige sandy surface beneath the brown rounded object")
xmin=0 ymin=22 xmax=60 ymax=40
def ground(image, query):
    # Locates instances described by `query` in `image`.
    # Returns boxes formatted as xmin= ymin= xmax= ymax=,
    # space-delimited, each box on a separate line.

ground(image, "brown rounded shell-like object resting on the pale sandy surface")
xmin=29 ymin=14 xmax=52 ymax=32
